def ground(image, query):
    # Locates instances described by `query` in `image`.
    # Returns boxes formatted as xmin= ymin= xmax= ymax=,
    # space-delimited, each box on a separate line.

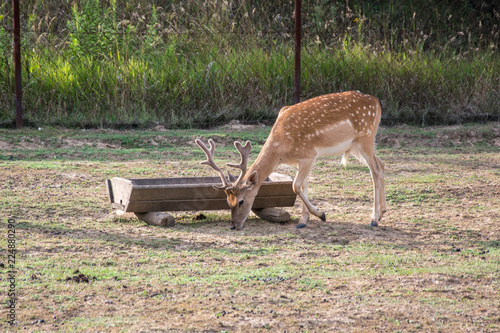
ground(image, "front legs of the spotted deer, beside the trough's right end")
xmin=293 ymin=158 xmax=326 ymax=229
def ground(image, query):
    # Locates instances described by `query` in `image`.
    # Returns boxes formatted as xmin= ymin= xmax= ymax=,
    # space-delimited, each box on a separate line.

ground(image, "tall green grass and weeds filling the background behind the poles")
xmin=0 ymin=0 xmax=500 ymax=127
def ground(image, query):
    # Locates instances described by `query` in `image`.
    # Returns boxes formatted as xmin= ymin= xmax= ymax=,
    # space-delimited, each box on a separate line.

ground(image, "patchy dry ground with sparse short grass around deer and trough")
xmin=0 ymin=123 xmax=500 ymax=332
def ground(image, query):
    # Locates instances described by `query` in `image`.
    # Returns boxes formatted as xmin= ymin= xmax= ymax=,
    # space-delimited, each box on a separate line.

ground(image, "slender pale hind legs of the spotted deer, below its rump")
xmin=351 ymin=142 xmax=386 ymax=227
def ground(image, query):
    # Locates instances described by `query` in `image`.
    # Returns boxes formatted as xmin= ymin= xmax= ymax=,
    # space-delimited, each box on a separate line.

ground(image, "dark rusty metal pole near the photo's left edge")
xmin=12 ymin=0 xmax=23 ymax=129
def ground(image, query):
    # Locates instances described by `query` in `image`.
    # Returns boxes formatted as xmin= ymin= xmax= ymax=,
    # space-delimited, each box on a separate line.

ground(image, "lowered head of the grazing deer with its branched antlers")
xmin=196 ymin=139 xmax=259 ymax=230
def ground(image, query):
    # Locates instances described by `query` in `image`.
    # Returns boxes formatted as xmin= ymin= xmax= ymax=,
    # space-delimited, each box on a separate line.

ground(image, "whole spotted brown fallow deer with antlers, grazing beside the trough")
xmin=196 ymin=91 xmax=386 ymax=230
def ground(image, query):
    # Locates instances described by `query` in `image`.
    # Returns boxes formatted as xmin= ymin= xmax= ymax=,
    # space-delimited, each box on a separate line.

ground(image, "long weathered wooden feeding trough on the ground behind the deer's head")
xmin=106 ymin=173 xmax=296 ymax=226
